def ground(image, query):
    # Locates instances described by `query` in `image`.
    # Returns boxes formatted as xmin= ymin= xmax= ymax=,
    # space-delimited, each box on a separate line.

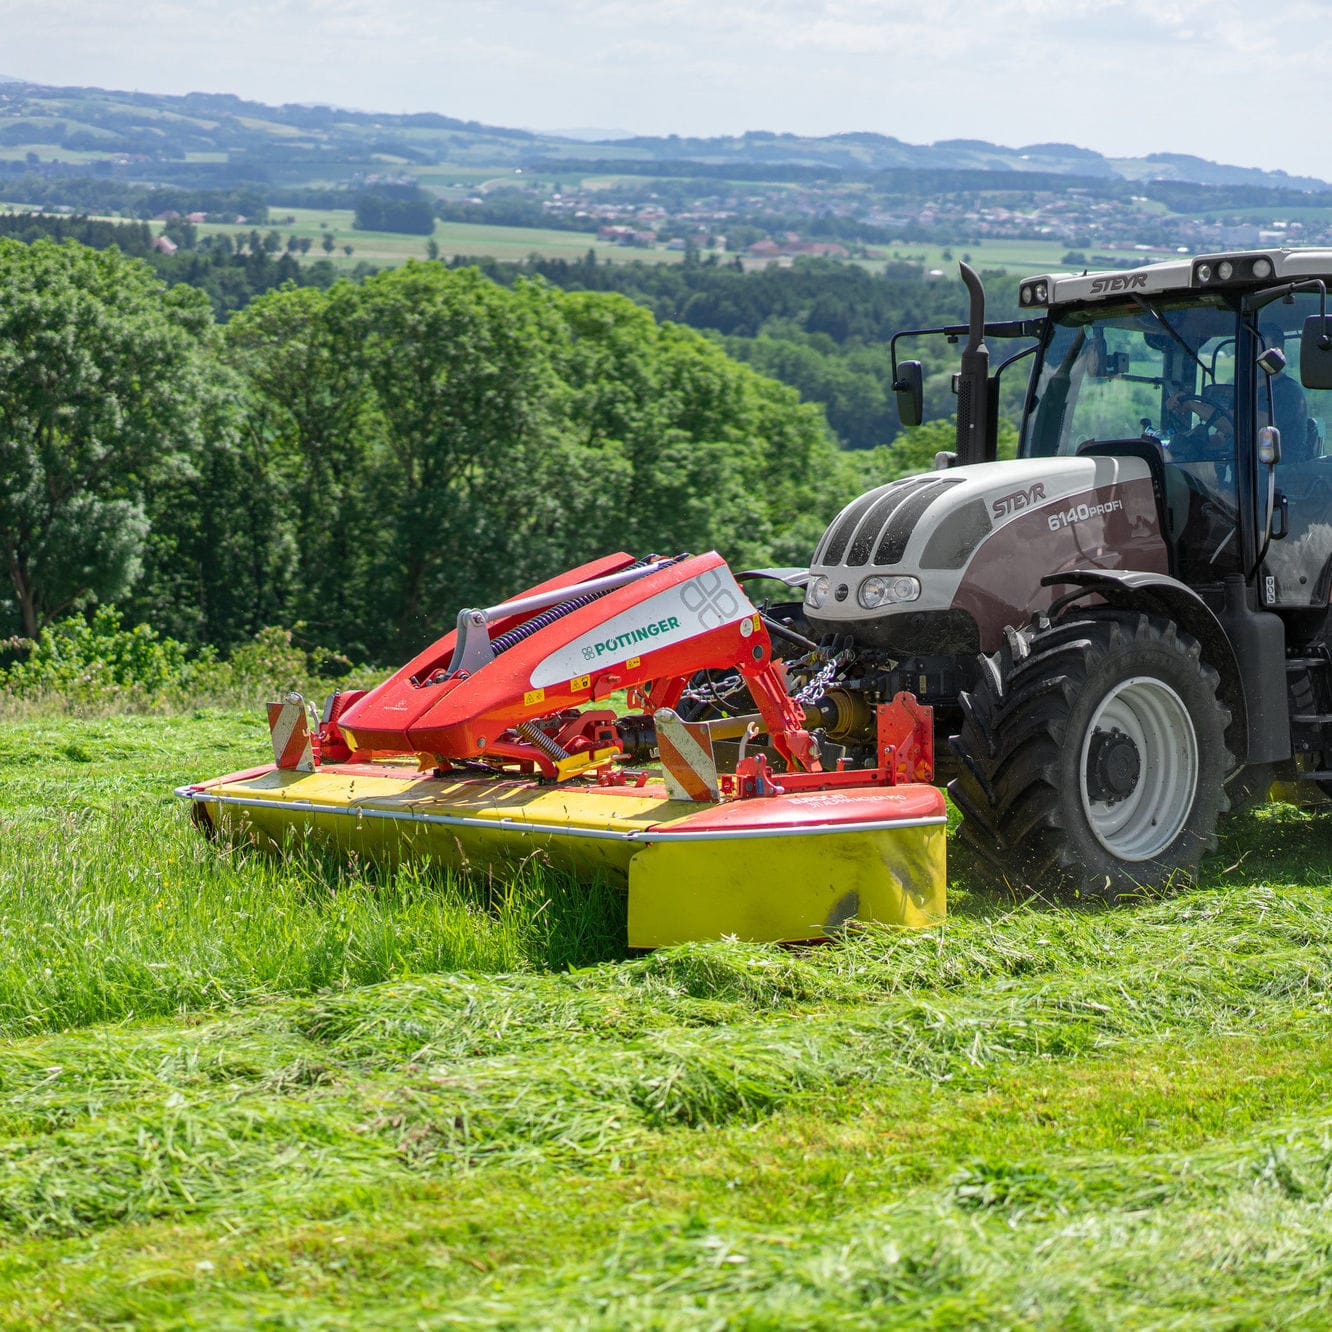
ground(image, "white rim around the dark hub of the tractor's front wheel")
xmin=1078 ymin=675 xmax=1197 ymax=860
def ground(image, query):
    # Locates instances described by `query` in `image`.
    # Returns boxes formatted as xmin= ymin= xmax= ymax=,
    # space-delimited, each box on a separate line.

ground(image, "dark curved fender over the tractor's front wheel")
xmin=1040 ymin=569 xmax=1291 ymax=763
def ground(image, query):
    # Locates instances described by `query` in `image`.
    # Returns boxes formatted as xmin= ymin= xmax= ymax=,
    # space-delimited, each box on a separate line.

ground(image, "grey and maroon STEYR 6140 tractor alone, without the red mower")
xmin=751 ymin=249 xmax=1332 ymax=900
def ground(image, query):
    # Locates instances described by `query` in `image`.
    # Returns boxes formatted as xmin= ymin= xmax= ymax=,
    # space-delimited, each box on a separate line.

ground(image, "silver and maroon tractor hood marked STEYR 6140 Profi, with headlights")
xmin=805 ymin=457 xmax=1168 ymax=654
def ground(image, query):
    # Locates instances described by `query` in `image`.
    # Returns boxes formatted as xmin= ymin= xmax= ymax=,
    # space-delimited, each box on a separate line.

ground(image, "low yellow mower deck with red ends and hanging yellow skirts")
xmin=177 ymin=763 xmax=946 ymax=947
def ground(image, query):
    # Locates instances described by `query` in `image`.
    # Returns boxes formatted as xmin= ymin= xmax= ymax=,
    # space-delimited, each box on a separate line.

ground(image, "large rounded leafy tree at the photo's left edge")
xmin=0 ymin=240 xmax=212 ymax=638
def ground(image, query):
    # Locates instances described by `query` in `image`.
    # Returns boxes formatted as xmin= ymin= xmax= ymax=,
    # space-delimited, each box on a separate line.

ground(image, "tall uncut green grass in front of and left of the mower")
xmin=0 ymin=717 xmax=625 ymax=1035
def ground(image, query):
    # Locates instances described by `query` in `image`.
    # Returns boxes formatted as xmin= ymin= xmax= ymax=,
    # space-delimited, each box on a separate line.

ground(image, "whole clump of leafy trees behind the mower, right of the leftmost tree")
xmin=225 ymin=261 xmax=857 ymax=661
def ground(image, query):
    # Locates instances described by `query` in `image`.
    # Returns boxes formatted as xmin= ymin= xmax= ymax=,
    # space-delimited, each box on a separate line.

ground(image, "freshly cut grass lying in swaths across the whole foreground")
xmin=0 ymin=891 xmax=1332 ymax=1327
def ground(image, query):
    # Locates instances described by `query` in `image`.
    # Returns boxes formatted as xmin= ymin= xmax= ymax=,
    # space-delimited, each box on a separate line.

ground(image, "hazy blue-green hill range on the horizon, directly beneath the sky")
xmin=0 ymin=76 xmax=1332 ymax=193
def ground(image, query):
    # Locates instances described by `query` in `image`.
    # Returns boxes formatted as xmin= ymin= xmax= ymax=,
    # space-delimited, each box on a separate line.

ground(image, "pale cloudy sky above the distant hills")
xmin=0 ymin=0 xmax=1332 ymax=180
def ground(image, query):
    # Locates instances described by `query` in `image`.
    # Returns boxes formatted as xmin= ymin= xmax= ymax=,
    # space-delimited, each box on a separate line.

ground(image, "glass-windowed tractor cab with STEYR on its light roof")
xmin=1020 ymin=250 xmax=1332 ymax=618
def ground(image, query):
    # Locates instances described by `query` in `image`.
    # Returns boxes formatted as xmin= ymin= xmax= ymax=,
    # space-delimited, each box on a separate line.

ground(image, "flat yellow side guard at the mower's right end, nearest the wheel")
xmin=629 ymin=826 xmax=947 ymax=948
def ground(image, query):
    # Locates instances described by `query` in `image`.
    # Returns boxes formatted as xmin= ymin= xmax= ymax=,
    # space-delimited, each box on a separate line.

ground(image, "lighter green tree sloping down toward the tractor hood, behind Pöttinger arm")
xmin=505 ymin=284 xmax=860 ymax=571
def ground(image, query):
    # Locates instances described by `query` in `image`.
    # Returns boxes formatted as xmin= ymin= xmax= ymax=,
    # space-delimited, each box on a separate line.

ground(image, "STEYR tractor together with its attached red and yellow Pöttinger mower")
xmin=190 ymin=249 xmax=1332 ymax=927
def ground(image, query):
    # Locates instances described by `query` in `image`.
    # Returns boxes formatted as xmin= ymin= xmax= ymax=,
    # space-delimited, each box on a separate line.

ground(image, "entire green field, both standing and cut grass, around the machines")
xmin=0 ymin=711 xmax=1332 ymax=1328
